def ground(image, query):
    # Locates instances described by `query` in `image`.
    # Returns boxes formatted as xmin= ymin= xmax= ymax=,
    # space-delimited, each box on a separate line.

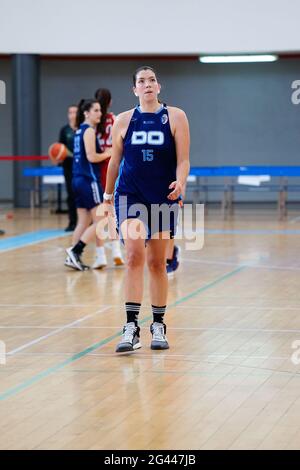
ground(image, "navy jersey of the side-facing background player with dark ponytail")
xmin=73 ymin=124 xmax=101 ymax=181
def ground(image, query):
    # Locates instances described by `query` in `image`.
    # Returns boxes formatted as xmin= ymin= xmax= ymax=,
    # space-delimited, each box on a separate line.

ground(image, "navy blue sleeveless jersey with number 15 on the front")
xmin=116 ymin=105 xmax=177 ymax=204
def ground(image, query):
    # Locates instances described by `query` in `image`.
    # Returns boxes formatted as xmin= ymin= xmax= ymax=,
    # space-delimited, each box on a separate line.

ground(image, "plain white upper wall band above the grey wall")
xmin=0 ymin=0 xmax=300 ymax=54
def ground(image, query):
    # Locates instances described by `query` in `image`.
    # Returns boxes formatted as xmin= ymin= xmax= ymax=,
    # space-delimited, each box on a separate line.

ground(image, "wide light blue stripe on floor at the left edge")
xmin=0 ymin=229 xmax=70 ymax=252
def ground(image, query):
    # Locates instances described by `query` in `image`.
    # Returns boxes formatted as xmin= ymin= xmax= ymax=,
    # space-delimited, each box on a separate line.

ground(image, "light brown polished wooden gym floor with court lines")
xmin=0 ymin=207 xmax=300 ymax=450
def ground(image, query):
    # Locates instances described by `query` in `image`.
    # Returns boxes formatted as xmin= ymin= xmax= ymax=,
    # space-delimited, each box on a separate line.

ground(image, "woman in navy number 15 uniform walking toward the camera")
xmin=104 ymin=66 xmax=189 ymax=352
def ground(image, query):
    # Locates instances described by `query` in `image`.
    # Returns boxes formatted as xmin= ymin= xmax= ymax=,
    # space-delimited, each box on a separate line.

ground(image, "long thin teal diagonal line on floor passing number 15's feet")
xmin=0 ymin=266 xmax=245 ymax=401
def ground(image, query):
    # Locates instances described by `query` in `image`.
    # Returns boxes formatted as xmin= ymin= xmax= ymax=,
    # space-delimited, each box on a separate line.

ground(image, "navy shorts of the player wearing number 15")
xmin=115 ymin=191 xmax=179 ymax=241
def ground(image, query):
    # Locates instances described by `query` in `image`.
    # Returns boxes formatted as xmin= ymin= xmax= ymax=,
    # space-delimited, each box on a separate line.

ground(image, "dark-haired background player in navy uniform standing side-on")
xmin=65 ymin=100 xmax=111 ymax=271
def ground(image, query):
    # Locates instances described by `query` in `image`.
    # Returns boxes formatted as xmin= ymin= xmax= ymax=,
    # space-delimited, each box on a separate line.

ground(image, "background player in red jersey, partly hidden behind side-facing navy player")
xmin=93 ymin=88 xmax=124 ymax=269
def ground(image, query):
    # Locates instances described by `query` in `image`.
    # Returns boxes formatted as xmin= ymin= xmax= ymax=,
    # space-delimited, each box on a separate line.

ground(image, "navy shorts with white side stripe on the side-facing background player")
xmin=72 ymin=176 xmax=103 ymax=210
